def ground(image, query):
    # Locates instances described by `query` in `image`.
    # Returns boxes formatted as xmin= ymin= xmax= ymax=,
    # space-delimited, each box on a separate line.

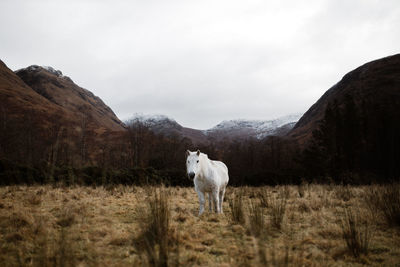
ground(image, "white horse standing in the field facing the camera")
xmin=186 ymin=150 xmax=229 ymax=215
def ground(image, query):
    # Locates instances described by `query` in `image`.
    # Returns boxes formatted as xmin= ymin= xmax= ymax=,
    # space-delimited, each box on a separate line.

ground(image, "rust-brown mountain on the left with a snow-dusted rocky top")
xmin=0 ymin=61 xmax=126 ymax=165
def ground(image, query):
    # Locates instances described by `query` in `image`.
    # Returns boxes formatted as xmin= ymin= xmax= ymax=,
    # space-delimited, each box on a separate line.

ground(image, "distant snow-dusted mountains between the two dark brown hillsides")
xmin=128 ymin=114 xmax=301 ymax=144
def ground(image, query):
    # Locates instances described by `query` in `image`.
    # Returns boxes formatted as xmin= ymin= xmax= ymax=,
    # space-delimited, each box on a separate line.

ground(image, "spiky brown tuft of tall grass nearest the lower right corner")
xmin=341 ymin=209 xmax=373 ymax=258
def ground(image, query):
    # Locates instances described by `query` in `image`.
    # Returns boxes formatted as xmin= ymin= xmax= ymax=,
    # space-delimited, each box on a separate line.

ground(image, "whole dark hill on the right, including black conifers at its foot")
xmin=289 ymin=54 xmax=400 ymax=182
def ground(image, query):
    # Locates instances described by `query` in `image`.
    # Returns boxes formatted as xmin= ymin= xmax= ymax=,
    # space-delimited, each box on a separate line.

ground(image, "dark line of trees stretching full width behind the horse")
xmin=0 ymin=96 xmax=400 ymax=186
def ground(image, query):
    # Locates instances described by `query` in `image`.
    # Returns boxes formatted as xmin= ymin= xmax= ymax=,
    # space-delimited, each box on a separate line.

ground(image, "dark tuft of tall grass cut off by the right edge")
xmin=364 ymin=183 xmax=400 ymax=226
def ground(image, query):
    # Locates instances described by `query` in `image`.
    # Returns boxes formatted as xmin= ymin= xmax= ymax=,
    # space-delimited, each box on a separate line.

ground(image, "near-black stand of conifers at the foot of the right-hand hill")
xmin=301 ymin=95 xmax=400 ymax=183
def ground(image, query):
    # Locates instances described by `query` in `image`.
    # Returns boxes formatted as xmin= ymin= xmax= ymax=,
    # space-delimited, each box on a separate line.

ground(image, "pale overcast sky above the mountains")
xmin=0 ymin=0 xmax=400 ymax=129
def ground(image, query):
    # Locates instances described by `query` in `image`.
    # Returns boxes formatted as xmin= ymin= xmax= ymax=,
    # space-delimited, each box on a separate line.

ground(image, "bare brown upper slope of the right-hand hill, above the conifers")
xmin=288 ymin=54 xmax=400 ymax=144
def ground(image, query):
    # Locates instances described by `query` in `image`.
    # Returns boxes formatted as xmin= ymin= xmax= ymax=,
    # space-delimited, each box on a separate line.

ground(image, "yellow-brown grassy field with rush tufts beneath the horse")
xmin=0 ymin=184 xmax=400 ymax=266
